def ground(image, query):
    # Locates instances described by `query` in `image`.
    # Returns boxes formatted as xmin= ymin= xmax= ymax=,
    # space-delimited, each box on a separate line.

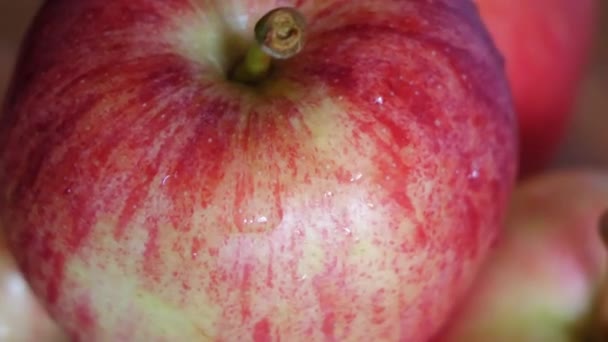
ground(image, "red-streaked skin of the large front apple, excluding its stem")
xmin=0 ymin=0 xmax=517 ymax=341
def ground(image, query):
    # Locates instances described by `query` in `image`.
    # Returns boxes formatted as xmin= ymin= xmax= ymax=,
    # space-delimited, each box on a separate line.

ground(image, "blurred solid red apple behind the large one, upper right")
xmin=475 ymin=0 xmax=599 ymax=177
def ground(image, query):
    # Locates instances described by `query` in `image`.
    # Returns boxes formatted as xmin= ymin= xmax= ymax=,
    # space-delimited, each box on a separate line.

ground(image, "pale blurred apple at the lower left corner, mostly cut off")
xmin=0 ymin=231 xmax=66 ymax=342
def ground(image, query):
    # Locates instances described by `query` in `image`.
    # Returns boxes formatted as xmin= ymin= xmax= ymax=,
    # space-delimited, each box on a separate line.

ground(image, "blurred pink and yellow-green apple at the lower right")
xmin=437 ymin=170 xmax=608 ymax=342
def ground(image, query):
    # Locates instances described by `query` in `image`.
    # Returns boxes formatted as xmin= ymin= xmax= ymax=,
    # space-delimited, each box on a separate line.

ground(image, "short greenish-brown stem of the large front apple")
xmin=231 ymin=7 xmax=306 ymax=83
